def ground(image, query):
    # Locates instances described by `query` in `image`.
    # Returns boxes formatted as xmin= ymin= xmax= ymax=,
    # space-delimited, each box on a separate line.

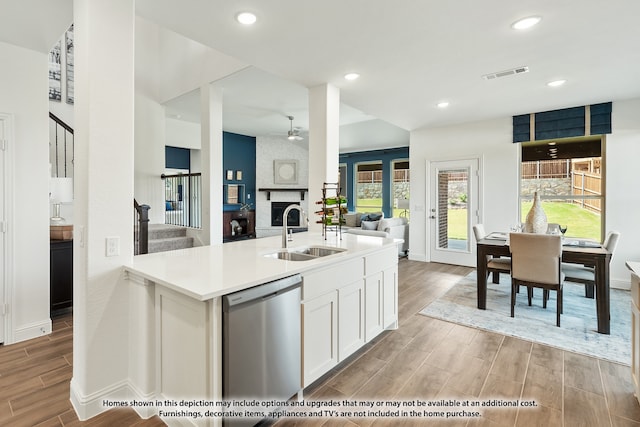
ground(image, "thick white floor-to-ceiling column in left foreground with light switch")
xmin=70 ymin=0 xmax=135 ymax=420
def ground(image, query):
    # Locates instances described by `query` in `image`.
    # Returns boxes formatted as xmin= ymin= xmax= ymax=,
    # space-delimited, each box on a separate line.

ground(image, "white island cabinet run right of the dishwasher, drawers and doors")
xmin=302 ymin=246 xmax=398 ymax=387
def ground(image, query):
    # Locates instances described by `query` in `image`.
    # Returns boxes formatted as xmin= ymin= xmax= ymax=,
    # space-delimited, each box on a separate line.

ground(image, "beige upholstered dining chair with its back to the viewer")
xmin=509 ymin=233 xmax=564 ymax=326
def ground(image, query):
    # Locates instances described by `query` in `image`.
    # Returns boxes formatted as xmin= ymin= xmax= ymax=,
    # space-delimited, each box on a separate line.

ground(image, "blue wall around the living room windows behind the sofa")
xmin=339 ymin=147 xmax=409 ymax=218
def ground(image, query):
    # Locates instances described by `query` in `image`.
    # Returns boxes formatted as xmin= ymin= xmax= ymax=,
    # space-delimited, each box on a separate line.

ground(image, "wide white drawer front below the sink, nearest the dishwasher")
xmin=302 ymin=258 xmax=364 ymax=300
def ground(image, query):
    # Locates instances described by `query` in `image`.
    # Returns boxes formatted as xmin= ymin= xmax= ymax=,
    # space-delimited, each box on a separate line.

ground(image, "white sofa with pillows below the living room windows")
xmin=344 ymin=212 xmax=409 ymax=256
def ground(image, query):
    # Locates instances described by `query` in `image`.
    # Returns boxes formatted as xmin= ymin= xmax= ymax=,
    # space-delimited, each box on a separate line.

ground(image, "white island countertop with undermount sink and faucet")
xmin=124 ymin=232 xmax=397 ymax=301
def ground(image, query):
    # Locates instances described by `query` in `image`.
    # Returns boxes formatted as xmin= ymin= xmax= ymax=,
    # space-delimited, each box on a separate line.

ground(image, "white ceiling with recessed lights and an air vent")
xmin=0 ymin=0 xmax=640 ymax=151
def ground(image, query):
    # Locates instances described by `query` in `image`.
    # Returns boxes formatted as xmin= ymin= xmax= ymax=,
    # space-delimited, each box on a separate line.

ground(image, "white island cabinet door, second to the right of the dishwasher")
xmin=338 ymin=279 xmax=364 ymax=361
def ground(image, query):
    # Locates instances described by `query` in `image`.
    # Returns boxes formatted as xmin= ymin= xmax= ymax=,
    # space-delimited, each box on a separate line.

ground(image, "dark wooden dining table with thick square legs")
xmin=476 ymin=232 xmax=611 ymax=334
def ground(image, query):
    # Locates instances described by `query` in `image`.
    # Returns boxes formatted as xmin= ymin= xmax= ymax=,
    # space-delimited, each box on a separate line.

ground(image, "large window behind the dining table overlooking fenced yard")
xmin=520 ymin=136 xmax=605 ymax=241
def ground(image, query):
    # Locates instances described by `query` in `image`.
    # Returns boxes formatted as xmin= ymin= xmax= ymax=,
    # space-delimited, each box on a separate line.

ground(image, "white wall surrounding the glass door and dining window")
xmin=409 ymin=99 xmax=640 ymax=287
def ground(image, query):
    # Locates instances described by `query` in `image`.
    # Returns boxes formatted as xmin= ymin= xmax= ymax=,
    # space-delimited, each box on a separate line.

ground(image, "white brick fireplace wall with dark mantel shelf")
xmin=254 ymin=136 xmax=316 ymax=237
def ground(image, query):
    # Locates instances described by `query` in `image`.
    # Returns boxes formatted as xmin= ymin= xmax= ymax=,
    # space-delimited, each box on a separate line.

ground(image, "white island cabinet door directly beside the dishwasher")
xmin=302 ymin=291 xmax=338 ymax=387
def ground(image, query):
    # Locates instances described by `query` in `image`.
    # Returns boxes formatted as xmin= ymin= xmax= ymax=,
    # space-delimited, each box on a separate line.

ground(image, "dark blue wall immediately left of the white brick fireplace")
xmin=222 ymin=132 xmax=256 ymax=211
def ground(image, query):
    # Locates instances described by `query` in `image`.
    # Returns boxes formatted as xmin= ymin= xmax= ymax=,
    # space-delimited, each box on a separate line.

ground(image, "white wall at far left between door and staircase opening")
xmin=0 ymin=42 xmax=51 ymax=342
